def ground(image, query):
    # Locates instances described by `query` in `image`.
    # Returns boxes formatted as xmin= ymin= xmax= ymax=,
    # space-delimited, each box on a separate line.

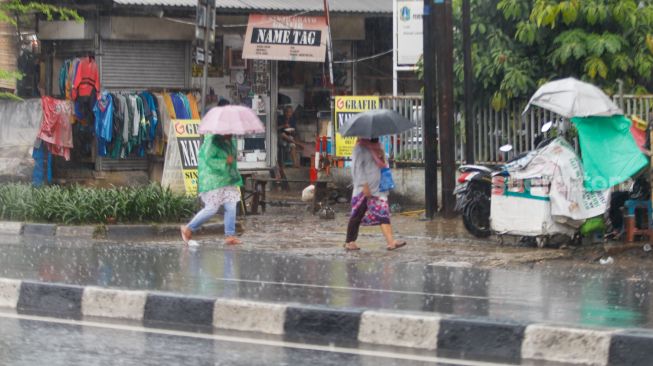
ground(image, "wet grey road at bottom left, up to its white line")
xmin=0 ymin=313 xmax=458 ymax=366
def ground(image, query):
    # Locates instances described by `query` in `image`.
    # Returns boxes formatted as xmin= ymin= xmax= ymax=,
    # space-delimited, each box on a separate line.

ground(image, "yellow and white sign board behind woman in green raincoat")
xmin=172 ymin=119 xmax=202 ymax=196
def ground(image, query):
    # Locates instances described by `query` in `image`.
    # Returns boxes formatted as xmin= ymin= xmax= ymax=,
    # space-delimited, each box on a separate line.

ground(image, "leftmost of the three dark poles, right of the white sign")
xmin=422 ymin=0 xmax=438 ymax=219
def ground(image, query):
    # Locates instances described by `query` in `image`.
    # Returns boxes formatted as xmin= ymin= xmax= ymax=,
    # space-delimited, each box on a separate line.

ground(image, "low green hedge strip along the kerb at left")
xmin=0 ymin=184 xmax=197 ymax=224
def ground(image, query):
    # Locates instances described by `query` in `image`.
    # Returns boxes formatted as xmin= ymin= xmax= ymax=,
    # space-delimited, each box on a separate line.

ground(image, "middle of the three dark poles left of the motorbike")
xmin=433 ymin=0 xmax=456 ymax=218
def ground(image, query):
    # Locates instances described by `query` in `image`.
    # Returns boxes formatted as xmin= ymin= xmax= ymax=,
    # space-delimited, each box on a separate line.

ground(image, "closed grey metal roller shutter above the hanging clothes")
xmin=101 ymin=41 xmax=190 ymax=89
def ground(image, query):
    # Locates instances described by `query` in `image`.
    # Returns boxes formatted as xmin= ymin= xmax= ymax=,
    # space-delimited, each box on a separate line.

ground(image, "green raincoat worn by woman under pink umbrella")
xmin=197 ymin=135 xmax=243 ymax=193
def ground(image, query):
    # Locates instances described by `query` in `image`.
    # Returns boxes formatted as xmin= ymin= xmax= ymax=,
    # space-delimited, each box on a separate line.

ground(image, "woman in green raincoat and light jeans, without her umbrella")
xmin=181 ymin=134 xmax=243 ymax=245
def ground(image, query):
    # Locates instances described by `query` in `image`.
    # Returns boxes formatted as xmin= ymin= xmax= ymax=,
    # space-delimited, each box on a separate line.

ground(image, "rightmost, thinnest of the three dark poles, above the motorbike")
xmin=463 ymin=0 xmax=475 ymax=164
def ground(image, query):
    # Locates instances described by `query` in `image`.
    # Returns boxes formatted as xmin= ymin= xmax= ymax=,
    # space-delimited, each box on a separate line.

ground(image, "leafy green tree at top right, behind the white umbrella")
xmin=419 ymin=0 xmax=653 ymax=109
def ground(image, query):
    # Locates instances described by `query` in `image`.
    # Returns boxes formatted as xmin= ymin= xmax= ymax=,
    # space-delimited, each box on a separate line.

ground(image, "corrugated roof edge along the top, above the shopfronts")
xmin=113 ymin=0 xmax=392 ymax=15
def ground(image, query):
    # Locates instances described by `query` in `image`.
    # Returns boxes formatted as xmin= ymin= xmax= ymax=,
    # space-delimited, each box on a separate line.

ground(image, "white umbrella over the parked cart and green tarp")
xmin=524 ymin=78 xmax=624 ymax=118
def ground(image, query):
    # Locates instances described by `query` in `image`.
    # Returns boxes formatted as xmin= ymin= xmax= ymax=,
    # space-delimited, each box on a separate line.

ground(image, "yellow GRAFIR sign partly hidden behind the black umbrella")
xmin=334 ymin=96 xmax=380 ymax=157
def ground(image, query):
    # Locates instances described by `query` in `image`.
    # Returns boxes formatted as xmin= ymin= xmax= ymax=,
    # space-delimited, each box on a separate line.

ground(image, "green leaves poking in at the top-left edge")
xmin=0 ymin=0 xmax=82 ymax=99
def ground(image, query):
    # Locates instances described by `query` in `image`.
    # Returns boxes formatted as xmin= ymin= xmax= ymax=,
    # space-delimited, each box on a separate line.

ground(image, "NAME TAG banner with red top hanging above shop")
xmin=242 ymin=14 xmax=329 ymax=62
